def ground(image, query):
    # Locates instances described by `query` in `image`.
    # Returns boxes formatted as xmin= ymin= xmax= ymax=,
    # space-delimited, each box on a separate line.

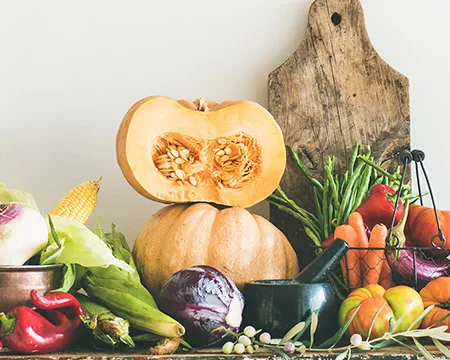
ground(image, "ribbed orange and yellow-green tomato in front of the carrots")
xmin=338 ymin=284 xmax=424 ymax=339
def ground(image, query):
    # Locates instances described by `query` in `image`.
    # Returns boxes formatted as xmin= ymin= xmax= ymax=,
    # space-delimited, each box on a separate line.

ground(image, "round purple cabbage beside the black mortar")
xmin=157 ymin=266 xmax=244 ymax=347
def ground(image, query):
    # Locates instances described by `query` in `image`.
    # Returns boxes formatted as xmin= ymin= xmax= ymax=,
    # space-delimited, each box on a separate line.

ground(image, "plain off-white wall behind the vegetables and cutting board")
xmin=0 ymin=0 xmax=450 ymax=246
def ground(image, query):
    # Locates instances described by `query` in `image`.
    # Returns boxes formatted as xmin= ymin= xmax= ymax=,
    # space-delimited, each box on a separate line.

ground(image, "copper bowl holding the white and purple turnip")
xmin=0 ymin=264 xmax=63 ymax=313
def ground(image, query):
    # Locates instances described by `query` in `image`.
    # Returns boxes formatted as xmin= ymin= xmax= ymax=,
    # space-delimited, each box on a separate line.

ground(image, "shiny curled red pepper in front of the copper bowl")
xmin=0 ymin=290 xmax=83 ymax=354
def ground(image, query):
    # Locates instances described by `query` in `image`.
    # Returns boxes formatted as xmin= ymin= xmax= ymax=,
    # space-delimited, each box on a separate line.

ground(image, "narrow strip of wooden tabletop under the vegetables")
xmin=0 ymin=347 xmax=445 ymax=360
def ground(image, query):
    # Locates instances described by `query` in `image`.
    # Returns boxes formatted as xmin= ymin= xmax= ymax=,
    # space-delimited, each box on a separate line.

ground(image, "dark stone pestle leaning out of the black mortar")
xmin=295 ymin=239 xmax=348 ymax=284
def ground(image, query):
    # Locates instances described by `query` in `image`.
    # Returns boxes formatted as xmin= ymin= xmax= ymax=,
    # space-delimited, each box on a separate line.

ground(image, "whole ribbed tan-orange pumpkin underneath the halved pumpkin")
xmin=133 ymin=203 xmax=299 ymax=296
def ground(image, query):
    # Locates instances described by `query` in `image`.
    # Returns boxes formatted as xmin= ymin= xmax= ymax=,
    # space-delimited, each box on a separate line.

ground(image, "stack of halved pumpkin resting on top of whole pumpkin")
xmin=116 ymin=96 xmax=299 ymax=295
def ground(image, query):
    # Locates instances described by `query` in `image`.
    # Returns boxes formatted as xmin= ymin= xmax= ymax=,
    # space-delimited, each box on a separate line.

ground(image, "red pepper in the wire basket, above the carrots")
xmin=322 ymin=184 xmax=404 ymax=247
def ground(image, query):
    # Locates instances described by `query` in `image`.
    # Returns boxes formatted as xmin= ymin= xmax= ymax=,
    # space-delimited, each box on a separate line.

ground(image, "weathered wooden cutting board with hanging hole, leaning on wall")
xmin=269 ymin=0 xmax=410 ymax=266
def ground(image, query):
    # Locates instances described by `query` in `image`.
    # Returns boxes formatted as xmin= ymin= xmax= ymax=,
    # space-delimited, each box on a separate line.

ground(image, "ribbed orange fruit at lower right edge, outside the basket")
xmin=420 ymin=276 xmax=450 ymax=332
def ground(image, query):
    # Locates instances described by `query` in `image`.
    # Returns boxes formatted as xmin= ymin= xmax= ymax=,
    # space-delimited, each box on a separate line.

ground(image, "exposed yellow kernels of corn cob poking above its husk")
xmin=50 ymin=177 xmax=102 ymax=224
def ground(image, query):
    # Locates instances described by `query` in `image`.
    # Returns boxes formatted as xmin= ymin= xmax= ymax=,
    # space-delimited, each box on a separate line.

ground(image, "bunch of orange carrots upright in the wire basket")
xmin=334 ymin=212 xmax=394 ymax=290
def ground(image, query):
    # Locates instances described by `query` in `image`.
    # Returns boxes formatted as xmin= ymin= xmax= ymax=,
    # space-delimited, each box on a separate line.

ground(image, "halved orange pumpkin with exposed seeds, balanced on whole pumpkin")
xmin=116 ymin=96 xmax=286 ymax=207
